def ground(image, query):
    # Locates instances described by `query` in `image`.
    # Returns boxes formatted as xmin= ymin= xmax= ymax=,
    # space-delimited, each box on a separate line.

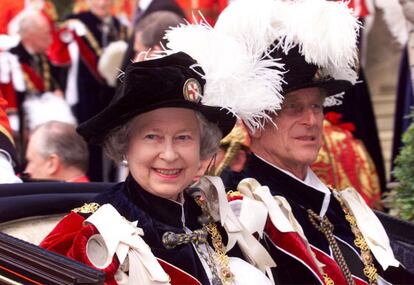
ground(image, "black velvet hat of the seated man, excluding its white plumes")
xmin=269 ymin=45 xmax=352 ymax=96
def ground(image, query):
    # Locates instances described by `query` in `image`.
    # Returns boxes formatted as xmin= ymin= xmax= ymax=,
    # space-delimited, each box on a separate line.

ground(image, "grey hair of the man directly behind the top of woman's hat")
xmin=135 ymin=11 xmax=185 ymax=48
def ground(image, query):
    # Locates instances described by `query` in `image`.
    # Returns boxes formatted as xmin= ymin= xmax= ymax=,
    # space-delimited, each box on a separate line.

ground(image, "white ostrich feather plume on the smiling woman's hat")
xmin=166 ymin=20 xmax=283 ymax=130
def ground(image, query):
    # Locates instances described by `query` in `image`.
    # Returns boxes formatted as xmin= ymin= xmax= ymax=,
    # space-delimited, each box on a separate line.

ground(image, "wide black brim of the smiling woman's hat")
xmin=77 ymin=100 xmax=236 ymax=145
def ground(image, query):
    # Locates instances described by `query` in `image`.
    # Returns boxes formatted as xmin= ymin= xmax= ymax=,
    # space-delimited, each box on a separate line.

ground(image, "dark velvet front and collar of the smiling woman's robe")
xmin=93 ymin=176 xmax=209 ymax=284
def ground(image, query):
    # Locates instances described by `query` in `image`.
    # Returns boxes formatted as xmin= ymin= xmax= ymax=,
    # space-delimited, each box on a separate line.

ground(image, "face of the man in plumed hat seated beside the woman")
xmin=252 ymin=88 xmax=324 ymax=179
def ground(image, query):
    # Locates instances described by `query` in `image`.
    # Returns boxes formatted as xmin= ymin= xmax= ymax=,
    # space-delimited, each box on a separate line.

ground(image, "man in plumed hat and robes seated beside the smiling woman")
xmin=215 ymin=0 xmax=414 ymax=284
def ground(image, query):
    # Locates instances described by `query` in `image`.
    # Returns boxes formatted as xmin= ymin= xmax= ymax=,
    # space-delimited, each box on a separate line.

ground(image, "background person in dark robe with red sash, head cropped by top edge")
xmin=61 ymin=0 xmax=127 ymax=123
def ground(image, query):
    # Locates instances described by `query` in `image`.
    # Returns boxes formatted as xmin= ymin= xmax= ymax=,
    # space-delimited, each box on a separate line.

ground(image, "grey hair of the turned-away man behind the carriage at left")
xmin=32 ymin=121 xmax=89 ymax=172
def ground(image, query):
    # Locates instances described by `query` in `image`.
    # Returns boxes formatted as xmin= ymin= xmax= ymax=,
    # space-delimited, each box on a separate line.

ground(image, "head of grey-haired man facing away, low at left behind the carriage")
xmin=26 ymin=121 xmax=89 ymax=182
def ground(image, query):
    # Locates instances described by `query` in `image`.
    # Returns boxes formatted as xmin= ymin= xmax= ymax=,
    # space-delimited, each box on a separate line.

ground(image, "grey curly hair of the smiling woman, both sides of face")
xmin=103 ymin=111 xmax=223 ymax=163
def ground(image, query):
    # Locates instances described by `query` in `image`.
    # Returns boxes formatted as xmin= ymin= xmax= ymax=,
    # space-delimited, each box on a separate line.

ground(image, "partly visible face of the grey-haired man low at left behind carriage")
xmin=25 ymin=131 xmax=51 ymax=179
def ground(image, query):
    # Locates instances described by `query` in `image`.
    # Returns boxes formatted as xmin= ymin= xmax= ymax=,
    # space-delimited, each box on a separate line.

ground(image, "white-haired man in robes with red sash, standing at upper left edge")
xmin=0 ymin=9 xmax=61 ymax=156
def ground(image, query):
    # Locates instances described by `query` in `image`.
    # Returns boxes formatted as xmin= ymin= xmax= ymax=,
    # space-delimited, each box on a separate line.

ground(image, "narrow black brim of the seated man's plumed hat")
xmin=283 ymin=79 xmax=352 ymax=97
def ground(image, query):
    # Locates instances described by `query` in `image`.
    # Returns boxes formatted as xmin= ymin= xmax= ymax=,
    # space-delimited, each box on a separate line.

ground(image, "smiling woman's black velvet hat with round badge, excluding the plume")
xmin=77 ymin=52 xmax=236 ymax=144
